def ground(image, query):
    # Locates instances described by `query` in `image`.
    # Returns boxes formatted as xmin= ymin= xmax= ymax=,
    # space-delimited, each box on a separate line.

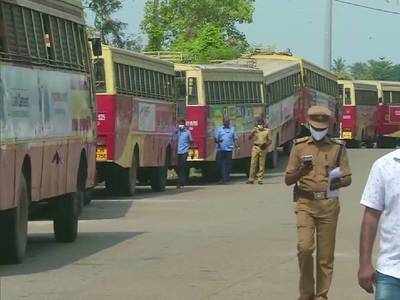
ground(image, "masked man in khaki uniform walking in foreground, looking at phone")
xmin=285 ymin=106 xmax=351 ymax=300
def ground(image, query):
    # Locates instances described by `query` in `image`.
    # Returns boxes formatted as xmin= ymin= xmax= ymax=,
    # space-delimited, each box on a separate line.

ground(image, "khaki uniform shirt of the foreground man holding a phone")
xmin=286 ymin=137 xmax=351 ymax=192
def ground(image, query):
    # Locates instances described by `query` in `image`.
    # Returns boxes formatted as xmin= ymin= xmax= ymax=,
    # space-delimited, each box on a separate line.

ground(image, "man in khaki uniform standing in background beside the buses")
xmin=247 ymin=118 xmax=271 ymax=184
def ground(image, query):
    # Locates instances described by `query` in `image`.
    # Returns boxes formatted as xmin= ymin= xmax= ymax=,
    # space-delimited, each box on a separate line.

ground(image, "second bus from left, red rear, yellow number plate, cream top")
xmin=94 ymin=46 xmax=177 ymax=195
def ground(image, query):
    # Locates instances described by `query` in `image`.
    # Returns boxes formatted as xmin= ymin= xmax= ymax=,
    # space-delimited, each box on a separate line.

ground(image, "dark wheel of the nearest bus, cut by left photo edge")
xmin=0 ymin=175 xmax=29 ymax=263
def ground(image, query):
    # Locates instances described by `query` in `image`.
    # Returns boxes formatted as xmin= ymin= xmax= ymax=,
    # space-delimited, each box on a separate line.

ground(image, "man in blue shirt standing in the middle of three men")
xmin=215 ymin=117 xmax=238 ymax=184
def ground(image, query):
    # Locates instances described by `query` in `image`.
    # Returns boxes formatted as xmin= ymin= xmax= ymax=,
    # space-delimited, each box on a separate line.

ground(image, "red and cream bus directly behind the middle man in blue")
xmin=175 ymin=65 xmax=265 ymax=179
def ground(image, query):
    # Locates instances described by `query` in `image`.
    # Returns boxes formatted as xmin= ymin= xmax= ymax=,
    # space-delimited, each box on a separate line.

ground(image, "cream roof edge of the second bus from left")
xmin=103 ymin=45 xmax=175 ymax=75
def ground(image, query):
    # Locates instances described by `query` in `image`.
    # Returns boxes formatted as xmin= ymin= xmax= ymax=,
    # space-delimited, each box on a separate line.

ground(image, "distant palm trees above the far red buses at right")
xmin=332 ymin=57 xmax=400 ymax=81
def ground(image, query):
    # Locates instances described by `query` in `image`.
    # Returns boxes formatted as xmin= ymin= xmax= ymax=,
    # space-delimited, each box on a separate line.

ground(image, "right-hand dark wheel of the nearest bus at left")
xmin=53 ymin=193 xmax=81 ymax=243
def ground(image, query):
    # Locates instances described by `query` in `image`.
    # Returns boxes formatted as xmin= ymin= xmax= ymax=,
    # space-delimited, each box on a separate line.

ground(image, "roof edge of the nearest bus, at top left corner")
xmin=5 ymin=0 xmax=85 ymax=25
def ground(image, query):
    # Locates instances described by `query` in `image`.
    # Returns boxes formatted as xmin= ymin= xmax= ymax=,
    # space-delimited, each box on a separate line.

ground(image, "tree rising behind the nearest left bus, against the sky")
xmin=85 ymin=0 xmax=141 ymax=50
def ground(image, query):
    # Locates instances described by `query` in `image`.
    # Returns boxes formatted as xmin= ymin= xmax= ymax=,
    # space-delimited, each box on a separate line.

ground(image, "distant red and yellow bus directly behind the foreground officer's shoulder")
xmin=339 ymin=80 xmax=379 ymax=147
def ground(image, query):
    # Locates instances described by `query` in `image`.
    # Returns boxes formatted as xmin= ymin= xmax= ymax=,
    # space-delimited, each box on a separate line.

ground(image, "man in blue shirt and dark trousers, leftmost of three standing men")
xmin=177 ymin=120 xmax=193 ymax=189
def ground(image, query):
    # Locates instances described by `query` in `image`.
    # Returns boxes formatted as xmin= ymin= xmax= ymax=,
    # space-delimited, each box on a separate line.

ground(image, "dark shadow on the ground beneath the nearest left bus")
xmin=0 ymin=232 xmax=144 ymax=277
